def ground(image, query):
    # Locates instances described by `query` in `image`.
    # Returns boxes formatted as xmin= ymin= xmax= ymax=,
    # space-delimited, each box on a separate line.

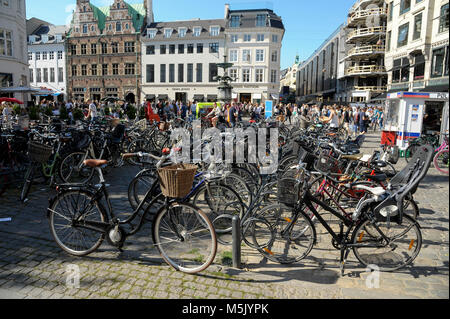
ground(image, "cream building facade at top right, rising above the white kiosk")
xmin=386 ymin=0 xmax=450 ymax=92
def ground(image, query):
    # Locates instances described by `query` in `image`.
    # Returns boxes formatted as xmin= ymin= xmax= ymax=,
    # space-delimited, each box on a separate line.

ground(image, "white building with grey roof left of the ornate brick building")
xmin=27 ymin=18 xmax=68 ymax=101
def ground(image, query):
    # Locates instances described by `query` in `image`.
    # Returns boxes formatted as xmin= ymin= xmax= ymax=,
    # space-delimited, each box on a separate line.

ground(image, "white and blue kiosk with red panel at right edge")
xmin=381 ymin=92 xmax=449 ymax=150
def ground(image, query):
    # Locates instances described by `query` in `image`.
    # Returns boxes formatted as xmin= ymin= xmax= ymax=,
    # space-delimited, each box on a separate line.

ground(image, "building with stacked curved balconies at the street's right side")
xmin=338 ymin=0 xmax=388 ymax=103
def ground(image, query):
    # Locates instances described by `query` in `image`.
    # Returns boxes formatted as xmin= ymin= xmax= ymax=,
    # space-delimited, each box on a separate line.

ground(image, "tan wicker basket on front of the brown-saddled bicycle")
xmin=158 ymin=164 xmax=197 ymax=198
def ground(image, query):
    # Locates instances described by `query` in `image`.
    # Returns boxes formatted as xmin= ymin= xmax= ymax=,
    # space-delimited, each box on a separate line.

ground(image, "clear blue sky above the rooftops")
xmin=27 ymin=0 xmax=355 ymax=69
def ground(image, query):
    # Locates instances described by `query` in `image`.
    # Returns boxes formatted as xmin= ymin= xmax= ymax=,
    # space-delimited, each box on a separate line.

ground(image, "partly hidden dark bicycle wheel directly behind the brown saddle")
xmin=58 ymin=152 xmax=94 ymax=184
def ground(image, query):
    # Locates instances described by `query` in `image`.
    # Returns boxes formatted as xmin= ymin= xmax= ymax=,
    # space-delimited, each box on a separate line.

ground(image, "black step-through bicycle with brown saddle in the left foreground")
xmin=47 ymin=153 xmax=217 ymax=274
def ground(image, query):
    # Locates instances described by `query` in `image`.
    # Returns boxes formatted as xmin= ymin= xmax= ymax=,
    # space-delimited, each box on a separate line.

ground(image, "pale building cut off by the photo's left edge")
xmin=0 ymin=0 xmax=28 ymax=101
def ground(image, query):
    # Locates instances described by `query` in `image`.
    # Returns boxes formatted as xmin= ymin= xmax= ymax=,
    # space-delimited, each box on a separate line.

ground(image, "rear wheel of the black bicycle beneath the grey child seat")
xmin=351 ymin=215 xmax=422 ymax=271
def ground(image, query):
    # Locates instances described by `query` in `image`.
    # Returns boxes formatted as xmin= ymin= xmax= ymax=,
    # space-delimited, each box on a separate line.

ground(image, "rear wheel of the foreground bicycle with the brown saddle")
xmin=48 ymin=191 xmax=108 ymax=256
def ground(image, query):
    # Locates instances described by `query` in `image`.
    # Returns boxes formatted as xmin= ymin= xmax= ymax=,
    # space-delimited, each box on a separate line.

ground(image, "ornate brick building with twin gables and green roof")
xmin=66 ymin=0 xmax=146 ymax=103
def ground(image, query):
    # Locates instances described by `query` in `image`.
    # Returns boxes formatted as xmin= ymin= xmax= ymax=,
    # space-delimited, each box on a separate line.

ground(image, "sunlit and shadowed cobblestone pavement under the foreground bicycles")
xmin=0 ymin=134 xmax=449 ymax=299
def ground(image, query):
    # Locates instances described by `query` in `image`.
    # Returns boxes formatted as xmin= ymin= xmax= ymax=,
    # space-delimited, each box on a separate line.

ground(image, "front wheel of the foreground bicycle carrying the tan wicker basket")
xmin=153 ymin=203 xmax=217 ymax=274
